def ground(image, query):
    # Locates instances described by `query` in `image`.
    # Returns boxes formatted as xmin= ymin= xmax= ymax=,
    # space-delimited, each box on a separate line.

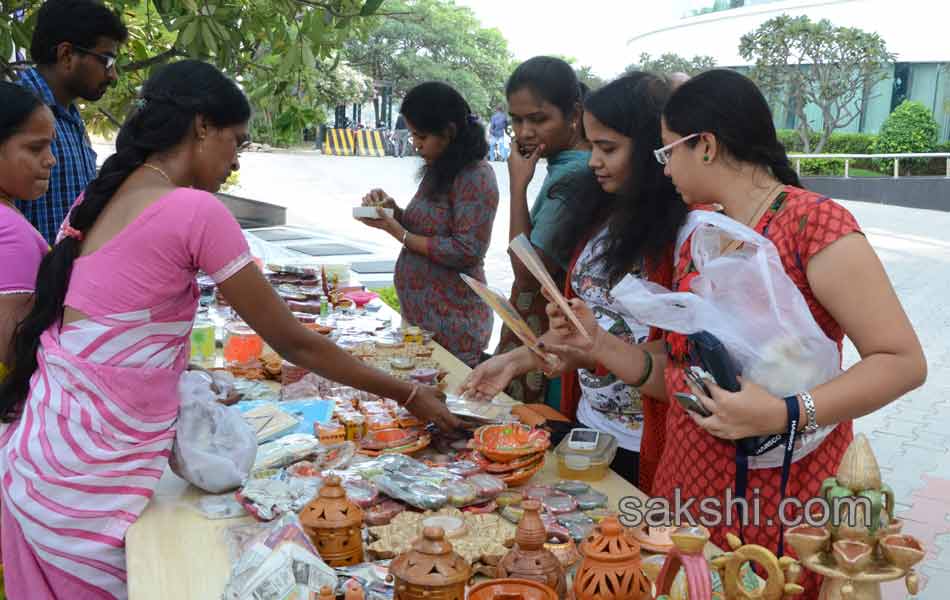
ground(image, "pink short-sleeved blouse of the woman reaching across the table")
xmin=65 ymin=188 xmax=251 ymax=321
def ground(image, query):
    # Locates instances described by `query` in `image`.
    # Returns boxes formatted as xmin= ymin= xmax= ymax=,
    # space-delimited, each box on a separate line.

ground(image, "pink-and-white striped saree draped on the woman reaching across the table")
xmin=0 ymin=311 xmax=191 ymax=599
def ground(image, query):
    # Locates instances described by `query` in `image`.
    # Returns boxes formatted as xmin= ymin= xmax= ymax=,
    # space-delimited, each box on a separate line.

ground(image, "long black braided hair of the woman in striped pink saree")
xmin=0 ymin=60 xmax=251 ymax=420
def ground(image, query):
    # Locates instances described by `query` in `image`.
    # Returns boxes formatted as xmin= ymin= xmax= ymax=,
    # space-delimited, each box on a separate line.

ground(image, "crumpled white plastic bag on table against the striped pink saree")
xmin=169 ymin=371 xmax=257 ymax=494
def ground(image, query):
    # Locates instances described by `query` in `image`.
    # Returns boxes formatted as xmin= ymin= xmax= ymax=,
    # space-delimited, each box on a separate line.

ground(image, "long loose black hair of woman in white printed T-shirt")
xmin=551 ymin=72 xmax=687 ymax=284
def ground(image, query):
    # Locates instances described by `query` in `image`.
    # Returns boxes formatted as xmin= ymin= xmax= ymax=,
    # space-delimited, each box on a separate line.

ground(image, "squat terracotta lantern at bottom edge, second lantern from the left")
xmin=387 ymin=527 xmax=472 ymax=600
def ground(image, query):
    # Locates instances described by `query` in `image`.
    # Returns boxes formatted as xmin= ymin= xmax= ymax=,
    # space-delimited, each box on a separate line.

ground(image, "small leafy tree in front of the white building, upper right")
xmin=739 ymin=15 xmax=894 ymax=152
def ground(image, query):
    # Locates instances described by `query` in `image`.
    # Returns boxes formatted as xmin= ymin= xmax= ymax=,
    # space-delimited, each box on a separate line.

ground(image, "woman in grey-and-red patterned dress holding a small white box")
xmin=360 ymin=82 xmax=498 ymax=367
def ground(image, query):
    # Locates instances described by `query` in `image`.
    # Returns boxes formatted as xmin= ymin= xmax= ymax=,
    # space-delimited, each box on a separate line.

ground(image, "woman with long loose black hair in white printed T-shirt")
xmin=463 ymin=73 xmax=686 ymax=490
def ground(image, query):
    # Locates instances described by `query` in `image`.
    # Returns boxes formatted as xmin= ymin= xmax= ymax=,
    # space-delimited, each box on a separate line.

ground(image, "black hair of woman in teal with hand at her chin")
xmin=505 ymin=56 xmax=587 ymax=120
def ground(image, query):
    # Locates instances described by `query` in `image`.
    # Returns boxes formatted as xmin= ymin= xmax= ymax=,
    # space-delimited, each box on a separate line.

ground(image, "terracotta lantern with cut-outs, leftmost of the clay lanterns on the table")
xmin=300 ymin=475 xmax=363 ymax=567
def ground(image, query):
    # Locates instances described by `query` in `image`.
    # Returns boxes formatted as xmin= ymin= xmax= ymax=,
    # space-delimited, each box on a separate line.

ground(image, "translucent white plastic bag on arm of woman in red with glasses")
xmin=611 ymin=211 xmax=841 ymax=468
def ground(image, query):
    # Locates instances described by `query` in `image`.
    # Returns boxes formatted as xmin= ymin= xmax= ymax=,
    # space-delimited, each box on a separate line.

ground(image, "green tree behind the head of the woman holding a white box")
xmin=344 ymin=0 xmax=512 ymax=115
